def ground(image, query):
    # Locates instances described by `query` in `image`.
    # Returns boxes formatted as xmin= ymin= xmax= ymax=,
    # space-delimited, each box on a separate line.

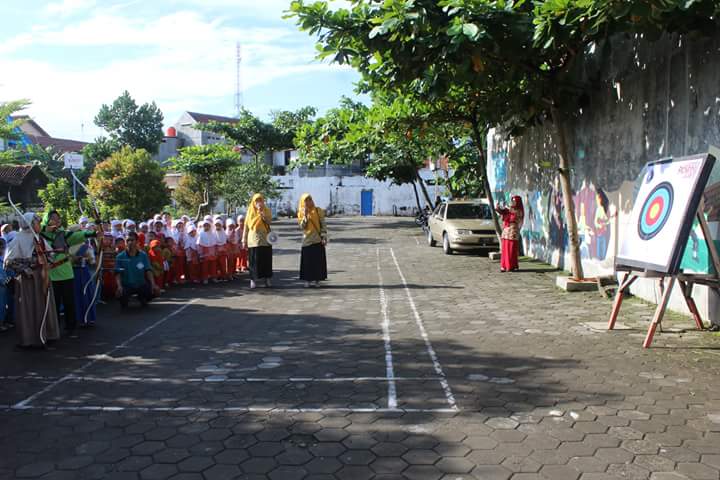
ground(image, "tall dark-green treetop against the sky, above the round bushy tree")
xmin=95 ymin=91 xmax=163 ymax=154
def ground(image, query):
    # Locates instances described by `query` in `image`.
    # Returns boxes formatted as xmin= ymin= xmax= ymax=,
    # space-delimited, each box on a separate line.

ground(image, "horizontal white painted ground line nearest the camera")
xmin=0 ymin=405 xmax=458 ymax=413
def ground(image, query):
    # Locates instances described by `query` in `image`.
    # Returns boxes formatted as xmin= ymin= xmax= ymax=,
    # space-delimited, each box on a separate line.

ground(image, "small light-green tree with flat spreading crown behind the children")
xmin=171 ymin=144 xmax=240 ymax=218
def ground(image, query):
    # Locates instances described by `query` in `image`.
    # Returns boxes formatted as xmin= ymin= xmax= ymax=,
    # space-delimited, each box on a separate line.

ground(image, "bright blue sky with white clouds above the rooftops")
xmin=0 ymin=0 xmax=359 ymax=141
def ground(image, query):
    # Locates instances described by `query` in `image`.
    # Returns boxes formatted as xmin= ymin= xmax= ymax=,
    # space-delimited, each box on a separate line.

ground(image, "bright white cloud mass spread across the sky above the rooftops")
xmin=0 ymin=7 xmax=352 ymax=140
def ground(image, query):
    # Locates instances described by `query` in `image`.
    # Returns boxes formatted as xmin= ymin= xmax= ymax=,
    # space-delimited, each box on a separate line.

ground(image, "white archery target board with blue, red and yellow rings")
xmin=615 ymin=154 xmax=715 ymax=274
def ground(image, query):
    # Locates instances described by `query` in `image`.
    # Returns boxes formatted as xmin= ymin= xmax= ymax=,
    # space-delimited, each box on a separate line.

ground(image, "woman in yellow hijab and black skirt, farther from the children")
xmin=298 ymin=193 xmax=327 ymax=288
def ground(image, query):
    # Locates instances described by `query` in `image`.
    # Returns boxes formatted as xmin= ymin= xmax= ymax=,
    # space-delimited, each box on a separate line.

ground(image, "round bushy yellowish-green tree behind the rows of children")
xmin=88 ymin=147 xmax=170 ymax=219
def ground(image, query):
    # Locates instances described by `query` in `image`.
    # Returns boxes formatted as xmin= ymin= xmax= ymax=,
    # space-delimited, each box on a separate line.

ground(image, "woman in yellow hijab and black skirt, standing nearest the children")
xmin=242 ymin=193 xmax=272 ymax=288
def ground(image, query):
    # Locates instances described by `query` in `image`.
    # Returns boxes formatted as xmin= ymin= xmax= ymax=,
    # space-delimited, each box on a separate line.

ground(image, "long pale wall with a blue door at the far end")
xmin=272 ymin=169 xmax=445 ymax=216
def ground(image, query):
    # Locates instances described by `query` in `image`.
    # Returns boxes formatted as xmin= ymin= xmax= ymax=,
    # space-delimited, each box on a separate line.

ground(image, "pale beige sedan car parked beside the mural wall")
xmin=427 ymin=200 xmax=500 ymax=255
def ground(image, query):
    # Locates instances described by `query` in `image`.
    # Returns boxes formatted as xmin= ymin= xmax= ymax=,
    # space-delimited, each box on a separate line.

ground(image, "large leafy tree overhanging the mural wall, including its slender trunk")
xmin=289 ymin=0 xmax=720 ymax=278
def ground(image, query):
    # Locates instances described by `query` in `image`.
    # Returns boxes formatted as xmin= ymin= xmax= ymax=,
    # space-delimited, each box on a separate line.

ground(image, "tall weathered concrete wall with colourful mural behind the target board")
xmin=488 ymin=31 xmax=720 ymax=316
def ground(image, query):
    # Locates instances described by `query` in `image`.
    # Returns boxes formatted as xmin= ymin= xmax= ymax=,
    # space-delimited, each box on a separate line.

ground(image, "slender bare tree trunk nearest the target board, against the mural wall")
xmin=550 ymin=104 xmax=585 ymax=280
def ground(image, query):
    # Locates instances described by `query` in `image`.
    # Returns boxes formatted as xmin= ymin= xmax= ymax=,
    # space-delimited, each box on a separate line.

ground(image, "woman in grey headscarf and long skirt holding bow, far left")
xmin=4 ymin=212 xmax=60 ymax=347
